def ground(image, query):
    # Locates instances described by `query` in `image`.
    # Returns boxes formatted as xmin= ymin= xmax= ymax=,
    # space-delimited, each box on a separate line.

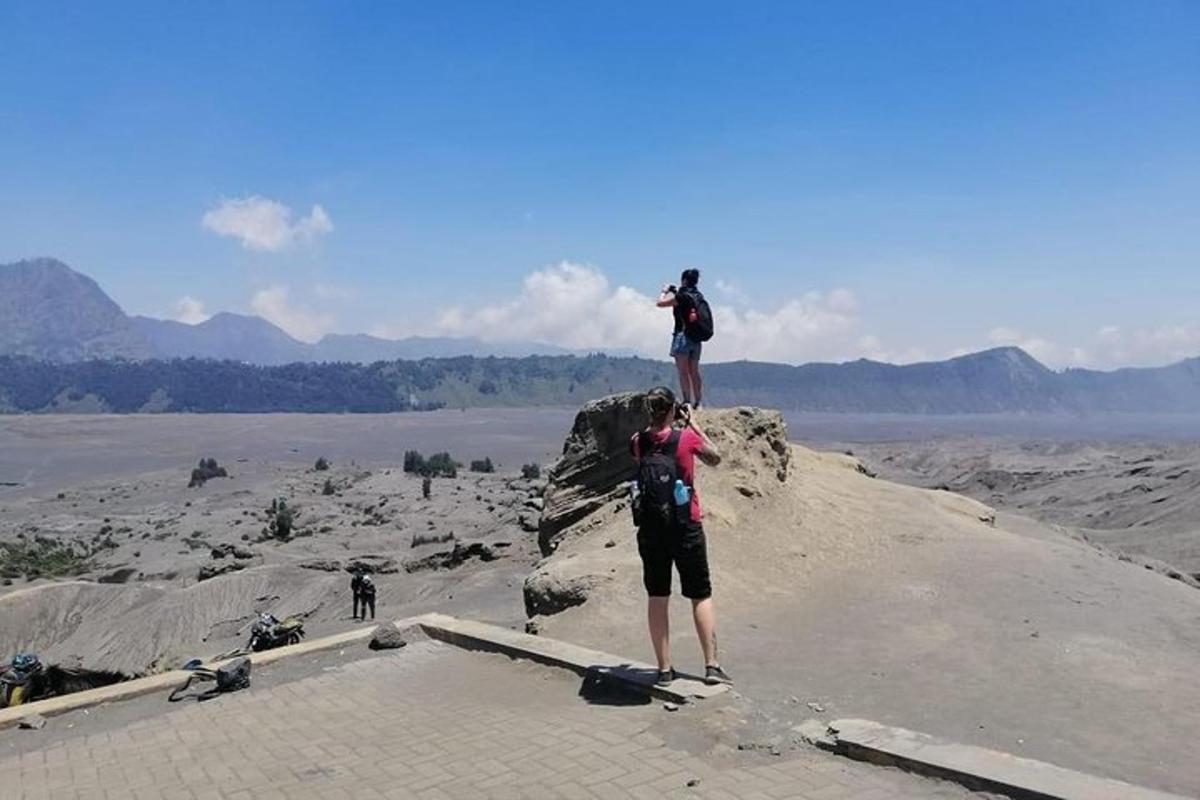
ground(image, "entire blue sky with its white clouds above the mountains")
xmin=0 ymin=0 xmax=1200 ymax=366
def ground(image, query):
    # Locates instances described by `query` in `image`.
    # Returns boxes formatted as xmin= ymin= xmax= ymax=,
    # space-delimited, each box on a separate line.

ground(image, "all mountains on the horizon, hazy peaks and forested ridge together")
xmin=0 ymin=260 xmax=1200 ymax=414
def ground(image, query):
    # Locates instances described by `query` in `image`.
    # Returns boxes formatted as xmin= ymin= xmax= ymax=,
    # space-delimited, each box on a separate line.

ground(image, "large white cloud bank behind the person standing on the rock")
xmin=422 ymin=261 xmax=862 ymax=363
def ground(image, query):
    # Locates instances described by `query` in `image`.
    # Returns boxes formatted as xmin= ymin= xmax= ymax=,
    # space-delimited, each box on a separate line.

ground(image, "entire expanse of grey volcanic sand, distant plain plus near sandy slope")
xmin=0 ymin=410 xmax=1200 ymax=794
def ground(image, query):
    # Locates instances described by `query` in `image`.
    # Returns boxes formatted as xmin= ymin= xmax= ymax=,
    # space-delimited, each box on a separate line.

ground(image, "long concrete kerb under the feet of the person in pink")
xmin=412 ymin=614 xmax=730 ymax=704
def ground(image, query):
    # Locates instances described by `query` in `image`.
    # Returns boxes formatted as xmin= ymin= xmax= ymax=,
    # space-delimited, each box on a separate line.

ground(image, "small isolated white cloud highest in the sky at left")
xmin=200 ymin=194 xmax=334 ymax=252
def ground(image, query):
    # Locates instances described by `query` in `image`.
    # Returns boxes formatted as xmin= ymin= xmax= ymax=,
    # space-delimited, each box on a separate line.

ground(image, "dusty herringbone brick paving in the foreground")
xmin=9 ymin=643 xmax=970 ymax=800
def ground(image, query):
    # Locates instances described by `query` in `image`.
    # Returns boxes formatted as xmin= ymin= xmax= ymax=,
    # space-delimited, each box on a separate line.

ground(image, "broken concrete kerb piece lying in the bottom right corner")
xmin=793 ymin=720 xmax=1187 ymax=800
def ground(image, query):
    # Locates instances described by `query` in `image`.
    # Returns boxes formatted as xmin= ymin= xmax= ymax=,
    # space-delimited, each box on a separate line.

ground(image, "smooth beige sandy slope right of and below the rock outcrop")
xmin=532 ymin=411 xmax=1200 ymax=795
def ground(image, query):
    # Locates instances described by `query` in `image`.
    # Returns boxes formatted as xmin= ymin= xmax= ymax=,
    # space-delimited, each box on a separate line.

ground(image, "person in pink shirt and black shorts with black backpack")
xmin=629 ymin=386 xmax=733 ymax=686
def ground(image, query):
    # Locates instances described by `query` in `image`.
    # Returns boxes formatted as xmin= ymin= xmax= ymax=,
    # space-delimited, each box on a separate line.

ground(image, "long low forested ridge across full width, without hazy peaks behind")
xmin=0 ymin=348 xmax=1200 ymax=414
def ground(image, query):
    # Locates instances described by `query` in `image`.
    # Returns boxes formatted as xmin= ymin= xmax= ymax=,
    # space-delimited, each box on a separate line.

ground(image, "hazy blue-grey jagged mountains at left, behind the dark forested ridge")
xmin=0 ymin=258 xmax=595 ymax=366
